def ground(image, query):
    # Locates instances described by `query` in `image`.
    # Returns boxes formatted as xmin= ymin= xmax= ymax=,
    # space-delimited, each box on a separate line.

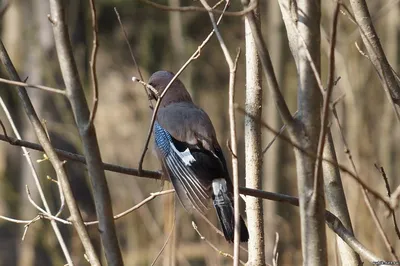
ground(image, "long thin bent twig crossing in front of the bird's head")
xmin=138 ymin=2 xmax=229 ymax=174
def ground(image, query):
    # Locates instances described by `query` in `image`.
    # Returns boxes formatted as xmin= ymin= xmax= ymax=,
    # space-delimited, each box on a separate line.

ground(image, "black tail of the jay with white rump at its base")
xmin=212 ymin=178 xmax=249 ymax=242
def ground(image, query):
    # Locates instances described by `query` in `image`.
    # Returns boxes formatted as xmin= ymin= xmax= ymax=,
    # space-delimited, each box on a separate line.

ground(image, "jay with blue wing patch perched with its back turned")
xmin=148 ymin=71 xmax=249 ymax=243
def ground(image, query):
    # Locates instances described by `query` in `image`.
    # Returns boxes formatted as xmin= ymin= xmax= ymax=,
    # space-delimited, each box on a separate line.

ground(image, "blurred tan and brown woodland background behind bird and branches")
xmin=0 ymin=0 xmax=400 ymax=266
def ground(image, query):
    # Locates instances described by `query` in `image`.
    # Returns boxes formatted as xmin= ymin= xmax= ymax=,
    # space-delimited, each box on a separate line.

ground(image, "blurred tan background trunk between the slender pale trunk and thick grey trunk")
xmin=263 ymin=1 xmax=287 ymax=262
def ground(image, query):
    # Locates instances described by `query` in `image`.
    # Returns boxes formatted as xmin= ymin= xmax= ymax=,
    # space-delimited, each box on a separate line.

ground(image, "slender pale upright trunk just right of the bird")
xmin=245 ymin=0 xmax=265 ymax=266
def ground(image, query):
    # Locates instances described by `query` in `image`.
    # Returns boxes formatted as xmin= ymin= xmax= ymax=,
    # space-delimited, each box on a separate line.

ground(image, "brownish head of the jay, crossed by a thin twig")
xmin=148 ymin=71 xmax=192 ymax=107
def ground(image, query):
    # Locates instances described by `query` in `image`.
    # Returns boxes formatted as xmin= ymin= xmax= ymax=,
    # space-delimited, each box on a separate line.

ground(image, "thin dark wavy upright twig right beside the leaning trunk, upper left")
xmin=87 ymin=0 xmax=99 ymax=127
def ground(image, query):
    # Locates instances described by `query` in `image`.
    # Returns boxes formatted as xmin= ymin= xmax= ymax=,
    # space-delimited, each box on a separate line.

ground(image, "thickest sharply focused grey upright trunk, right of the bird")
xmin=279 ymin=0 xmax=327 ymax=265
